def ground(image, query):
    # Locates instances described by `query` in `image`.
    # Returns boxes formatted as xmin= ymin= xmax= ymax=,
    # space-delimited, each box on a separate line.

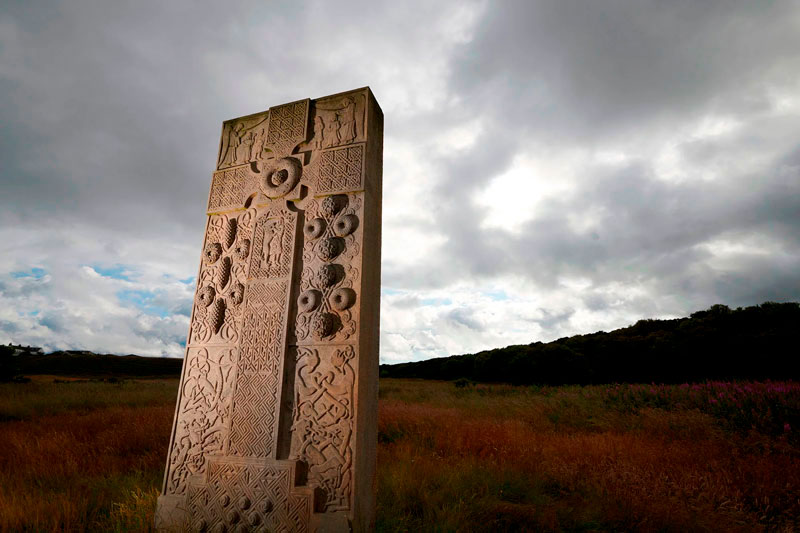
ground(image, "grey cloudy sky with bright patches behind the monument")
xmin=0 ymin=0 xmax=800 ymax=363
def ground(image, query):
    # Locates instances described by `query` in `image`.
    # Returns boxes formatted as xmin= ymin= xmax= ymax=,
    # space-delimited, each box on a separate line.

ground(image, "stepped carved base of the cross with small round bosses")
xmin=188 ymin=460 xmax=314 ymax=533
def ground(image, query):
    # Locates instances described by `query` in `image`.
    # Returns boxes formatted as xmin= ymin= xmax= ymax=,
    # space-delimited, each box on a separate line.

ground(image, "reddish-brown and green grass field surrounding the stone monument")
xmin=0 ymin=377 xmax=800 ymax=531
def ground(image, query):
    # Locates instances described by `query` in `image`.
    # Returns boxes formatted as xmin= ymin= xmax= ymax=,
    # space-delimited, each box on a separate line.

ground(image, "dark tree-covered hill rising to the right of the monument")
xmin=380 ymin=302 xmax=800 ymax=385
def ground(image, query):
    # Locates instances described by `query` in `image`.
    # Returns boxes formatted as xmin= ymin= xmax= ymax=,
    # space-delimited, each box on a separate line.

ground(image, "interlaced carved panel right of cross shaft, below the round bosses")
xmin=290 ymin=346 xmax=355 ymax=511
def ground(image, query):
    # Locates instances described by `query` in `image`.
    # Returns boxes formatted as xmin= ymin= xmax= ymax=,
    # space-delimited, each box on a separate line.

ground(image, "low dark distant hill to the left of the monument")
xmin=0 ymin=347 xmax=183 ymax=380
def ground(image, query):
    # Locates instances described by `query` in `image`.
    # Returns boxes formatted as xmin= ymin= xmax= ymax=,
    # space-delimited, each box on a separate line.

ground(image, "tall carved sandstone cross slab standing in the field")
xmin=156 ymin=88 xmax=383 ymax=532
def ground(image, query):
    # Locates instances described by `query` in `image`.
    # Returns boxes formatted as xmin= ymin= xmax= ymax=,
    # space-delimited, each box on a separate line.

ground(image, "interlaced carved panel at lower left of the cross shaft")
xmin=166 ymin=348 xmax=236 ymax=494
